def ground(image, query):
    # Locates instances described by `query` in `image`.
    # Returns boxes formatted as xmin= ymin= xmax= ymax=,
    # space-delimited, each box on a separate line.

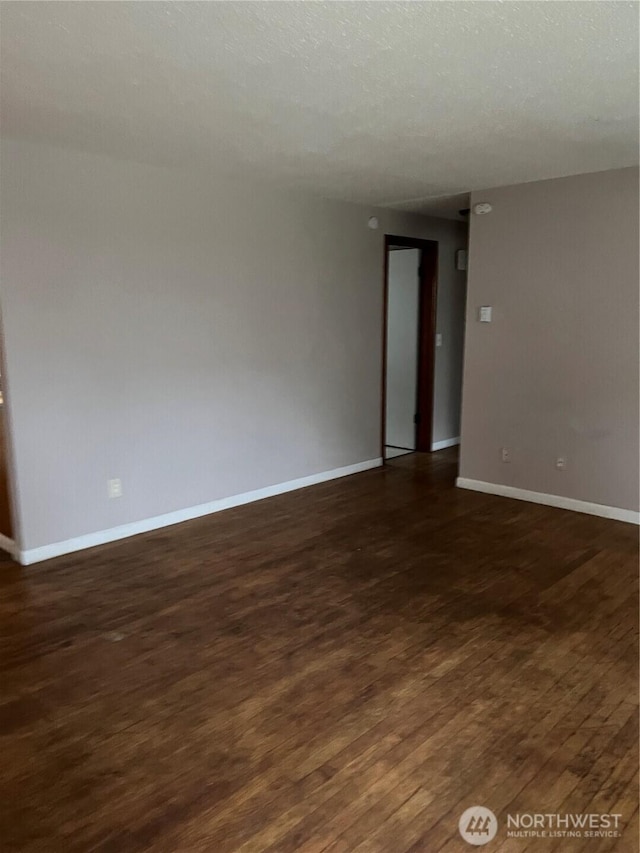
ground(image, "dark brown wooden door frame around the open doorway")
xmin=380 ymin=234 xmax=438 ymax=464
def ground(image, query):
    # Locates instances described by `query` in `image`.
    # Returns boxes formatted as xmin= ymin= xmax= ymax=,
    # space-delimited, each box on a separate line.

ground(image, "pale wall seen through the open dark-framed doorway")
xmin=385 ymin=249 xmax=420 ymax=450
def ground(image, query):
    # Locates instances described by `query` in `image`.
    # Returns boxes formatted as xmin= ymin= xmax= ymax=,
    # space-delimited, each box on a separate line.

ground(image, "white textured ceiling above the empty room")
xmin=1 ymin=0 xmax=640 ymax=216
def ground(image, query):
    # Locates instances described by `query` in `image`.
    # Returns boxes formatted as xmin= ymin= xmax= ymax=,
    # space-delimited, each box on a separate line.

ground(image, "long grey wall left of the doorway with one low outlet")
xmin=0 ymin=140 xmax=464 ymax=549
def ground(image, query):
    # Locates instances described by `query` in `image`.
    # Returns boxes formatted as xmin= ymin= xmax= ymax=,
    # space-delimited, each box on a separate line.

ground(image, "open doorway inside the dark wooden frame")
xmin=382 ymin=235 xmax=438 ymax=459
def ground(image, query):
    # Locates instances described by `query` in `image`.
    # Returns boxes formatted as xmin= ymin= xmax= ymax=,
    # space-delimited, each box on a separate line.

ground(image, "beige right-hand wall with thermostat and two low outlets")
xmin=460 ymin=169 xmax=639 ymax=510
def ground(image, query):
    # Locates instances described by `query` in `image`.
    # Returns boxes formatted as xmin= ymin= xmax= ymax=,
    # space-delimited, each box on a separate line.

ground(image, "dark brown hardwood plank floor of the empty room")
xmin=0 ymin=449 xmax=638 ymax=853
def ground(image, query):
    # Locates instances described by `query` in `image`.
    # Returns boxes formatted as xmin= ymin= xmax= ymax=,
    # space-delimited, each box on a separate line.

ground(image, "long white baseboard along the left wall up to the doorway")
xmin=17 ymin=457 xmax=382 ymax=566
